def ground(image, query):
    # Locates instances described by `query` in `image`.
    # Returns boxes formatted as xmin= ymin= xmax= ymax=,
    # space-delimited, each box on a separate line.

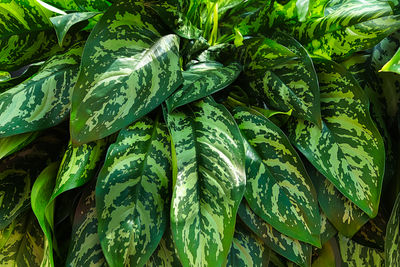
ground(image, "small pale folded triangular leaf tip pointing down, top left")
xmin=50 ymin=12 xmax=100 ymax=46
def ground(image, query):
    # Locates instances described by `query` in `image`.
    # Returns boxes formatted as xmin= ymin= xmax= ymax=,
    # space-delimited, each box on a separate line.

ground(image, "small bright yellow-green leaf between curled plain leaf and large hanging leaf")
xmin=51 ymin=139 xmax=107 ymax=203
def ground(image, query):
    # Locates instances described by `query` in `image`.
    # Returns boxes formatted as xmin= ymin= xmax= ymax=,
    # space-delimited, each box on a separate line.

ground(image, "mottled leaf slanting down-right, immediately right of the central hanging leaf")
xmin=233 ymin=107 xmax=321 ymax=246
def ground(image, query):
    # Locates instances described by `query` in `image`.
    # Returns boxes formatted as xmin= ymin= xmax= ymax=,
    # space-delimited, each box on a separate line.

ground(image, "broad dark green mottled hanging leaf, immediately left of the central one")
xmin=96 ymin=117 xmax=172 ymax=266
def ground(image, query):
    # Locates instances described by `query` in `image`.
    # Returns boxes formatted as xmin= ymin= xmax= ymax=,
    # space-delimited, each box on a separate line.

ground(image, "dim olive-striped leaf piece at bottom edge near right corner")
xmin=338 ymin=234 xmax=384 ymax=267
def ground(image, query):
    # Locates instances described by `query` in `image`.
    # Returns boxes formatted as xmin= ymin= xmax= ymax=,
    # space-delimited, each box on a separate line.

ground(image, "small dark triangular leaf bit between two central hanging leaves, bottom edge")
xmin=146 ymin=227 xmax=182 ymax=267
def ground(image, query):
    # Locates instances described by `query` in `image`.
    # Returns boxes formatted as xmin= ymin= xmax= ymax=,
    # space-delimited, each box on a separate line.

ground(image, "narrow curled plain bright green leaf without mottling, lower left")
xmin=31 ymin=162 xmax=59 ymax=266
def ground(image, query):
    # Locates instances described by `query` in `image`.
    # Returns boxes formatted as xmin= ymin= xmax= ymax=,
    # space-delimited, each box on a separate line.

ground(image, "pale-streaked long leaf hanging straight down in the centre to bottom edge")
xmin=168 ymin=98 xmax=246 ymax=267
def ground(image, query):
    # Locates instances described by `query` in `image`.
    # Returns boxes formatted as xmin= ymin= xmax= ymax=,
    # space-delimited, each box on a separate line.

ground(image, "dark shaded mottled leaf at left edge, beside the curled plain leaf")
xmin=0 ymin=169 xmax=31 ymax=229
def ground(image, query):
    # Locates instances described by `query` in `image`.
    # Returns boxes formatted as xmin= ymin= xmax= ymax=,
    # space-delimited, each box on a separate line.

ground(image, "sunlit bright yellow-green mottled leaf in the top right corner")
xmin=292 ymin=0 xmax=400 ymax=59
